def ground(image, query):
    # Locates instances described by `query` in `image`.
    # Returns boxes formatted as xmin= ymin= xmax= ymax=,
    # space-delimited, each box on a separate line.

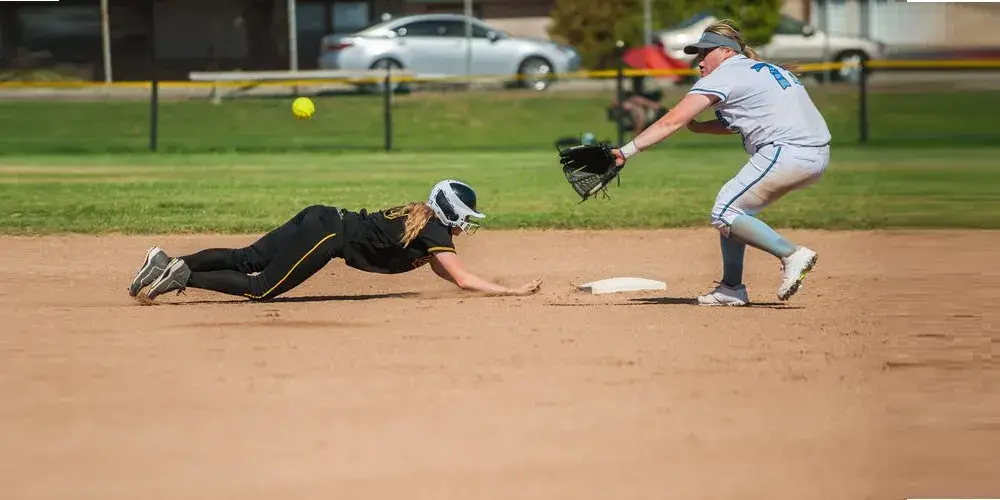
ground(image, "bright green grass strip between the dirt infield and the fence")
xmin=0 ymin=143 xmax=1000 ymax=234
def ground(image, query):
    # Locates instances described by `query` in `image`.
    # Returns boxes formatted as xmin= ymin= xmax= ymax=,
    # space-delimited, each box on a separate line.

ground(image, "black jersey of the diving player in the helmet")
xmin=342 ymin=206 xmax=455 ymax=274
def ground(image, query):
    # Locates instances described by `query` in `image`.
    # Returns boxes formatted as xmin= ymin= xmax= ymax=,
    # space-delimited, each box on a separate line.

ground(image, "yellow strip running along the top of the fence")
xmin=0 ymin=59 xmax=1000 ymax=89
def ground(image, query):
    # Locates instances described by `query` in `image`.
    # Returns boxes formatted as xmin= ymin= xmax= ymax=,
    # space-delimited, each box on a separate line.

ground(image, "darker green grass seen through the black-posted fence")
xmin=0 ymin=86 xmax=1000 ymax=155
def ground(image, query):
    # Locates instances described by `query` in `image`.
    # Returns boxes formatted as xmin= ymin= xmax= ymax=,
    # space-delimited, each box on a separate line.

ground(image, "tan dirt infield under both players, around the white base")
xmin=0 ymin=228 xmax=1000 ymax=500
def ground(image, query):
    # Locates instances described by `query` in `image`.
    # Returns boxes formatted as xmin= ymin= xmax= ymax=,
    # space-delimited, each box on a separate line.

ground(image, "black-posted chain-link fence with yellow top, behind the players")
xmin=0 ymin=61 xmax=1000 ymax=154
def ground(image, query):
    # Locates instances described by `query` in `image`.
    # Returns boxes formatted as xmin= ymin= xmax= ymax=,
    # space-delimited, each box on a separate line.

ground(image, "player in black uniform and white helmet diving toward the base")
xmin=129 ymin=180 xmax=542 ymax=302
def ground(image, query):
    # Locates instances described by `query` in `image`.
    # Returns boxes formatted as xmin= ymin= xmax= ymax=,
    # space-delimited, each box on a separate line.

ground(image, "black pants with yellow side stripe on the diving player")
xmin=181 ymin=205 xmax=344 ymax=300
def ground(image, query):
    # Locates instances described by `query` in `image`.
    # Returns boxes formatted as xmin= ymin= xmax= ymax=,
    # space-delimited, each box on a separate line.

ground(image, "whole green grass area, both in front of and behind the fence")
xmin=0 ymin=76 xmax=1000 ymax=234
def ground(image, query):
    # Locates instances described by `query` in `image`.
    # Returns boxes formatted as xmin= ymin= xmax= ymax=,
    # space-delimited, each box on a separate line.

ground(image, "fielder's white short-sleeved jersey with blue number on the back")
xmin=688 ymin=54 xmax=830 ymax=155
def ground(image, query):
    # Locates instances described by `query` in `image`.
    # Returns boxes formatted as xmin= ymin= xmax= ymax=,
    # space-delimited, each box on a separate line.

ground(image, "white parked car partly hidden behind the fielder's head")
xmin=654 ymin=12 xmax=886 ymax=81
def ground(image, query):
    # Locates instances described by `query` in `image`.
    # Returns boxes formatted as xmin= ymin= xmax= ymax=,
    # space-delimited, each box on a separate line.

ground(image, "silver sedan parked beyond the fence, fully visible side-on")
xmin=319 ymin=14 xmax=580 ymax=90
